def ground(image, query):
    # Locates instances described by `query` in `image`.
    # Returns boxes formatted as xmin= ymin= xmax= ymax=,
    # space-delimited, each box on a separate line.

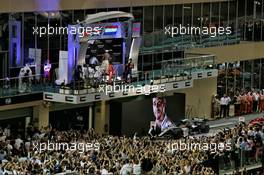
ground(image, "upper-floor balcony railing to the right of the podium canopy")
xmin=140 ymin=29 xmax=242 ymax=55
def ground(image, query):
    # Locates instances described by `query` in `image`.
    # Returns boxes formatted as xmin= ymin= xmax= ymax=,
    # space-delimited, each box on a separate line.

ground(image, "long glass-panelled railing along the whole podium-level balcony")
xmin=0 ymin=55 xmax=215 ymax=97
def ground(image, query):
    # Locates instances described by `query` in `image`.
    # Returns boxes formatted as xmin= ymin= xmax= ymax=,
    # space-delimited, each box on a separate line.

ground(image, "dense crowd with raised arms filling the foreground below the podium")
xmin=0 ymin=119 xmax=264 ymax=175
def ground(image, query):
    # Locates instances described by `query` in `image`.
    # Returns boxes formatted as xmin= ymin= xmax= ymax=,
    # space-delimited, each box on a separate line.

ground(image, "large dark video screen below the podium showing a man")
xmin=110 ymin=93 xmax=185 ymax=136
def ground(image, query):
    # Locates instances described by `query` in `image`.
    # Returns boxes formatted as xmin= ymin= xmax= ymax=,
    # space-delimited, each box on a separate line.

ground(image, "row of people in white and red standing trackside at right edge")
xmin=212 ymin=91 xmax=264 ymax=118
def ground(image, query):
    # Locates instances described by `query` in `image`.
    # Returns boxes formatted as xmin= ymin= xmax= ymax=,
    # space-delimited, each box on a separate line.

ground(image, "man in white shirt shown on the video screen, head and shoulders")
xmin=152 ymin=97 xmax=174 ymax=132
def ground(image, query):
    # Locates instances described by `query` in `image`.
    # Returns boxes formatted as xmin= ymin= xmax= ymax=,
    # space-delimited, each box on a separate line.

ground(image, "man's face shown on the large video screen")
xmin=152 ymin=97 xmax=166 ymax=122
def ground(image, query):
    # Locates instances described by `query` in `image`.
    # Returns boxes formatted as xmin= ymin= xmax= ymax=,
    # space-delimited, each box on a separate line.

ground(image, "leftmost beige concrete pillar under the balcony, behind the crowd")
xmin=33 ymin=105 xmax=49 ymax=129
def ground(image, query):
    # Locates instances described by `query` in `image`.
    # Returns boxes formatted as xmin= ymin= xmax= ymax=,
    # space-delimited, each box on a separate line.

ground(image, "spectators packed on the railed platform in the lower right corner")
xmin=221 ymin=123 xmax=264 ymax=172
